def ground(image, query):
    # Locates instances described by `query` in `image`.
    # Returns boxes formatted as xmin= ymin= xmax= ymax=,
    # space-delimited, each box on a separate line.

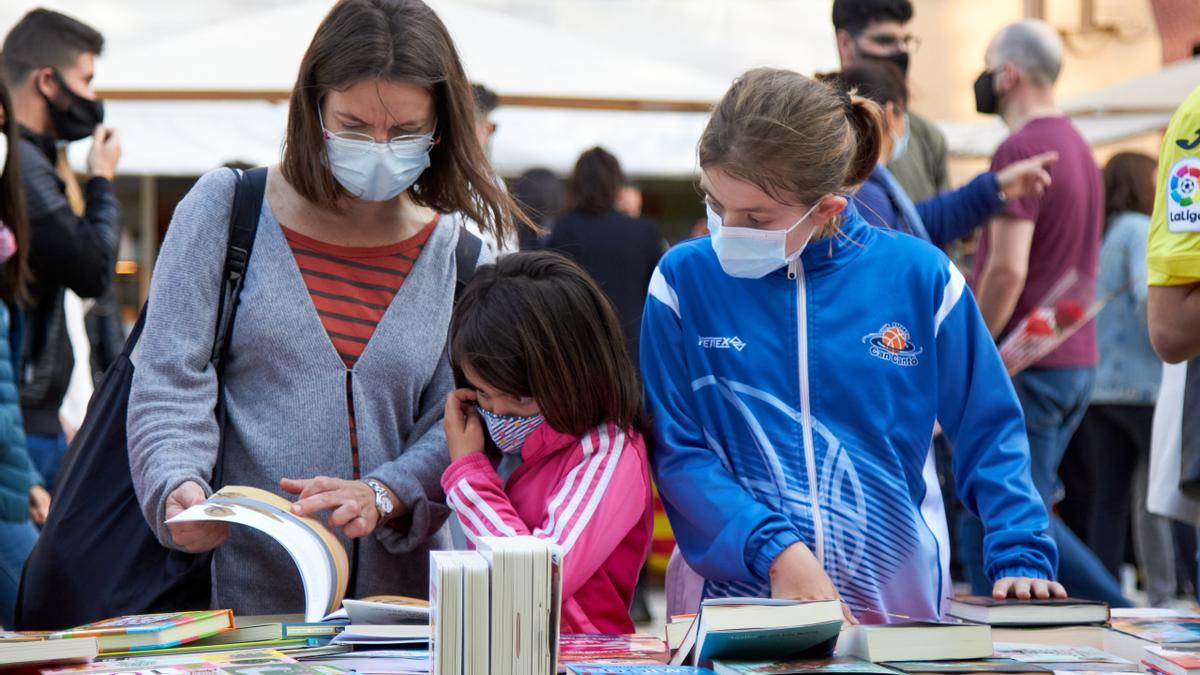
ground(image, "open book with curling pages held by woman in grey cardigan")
xmin=167 ymin=485 xmax=350 ymax=622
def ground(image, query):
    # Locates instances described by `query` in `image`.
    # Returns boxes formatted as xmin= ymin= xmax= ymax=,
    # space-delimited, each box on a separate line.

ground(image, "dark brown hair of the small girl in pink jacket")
xmin=450 ymin=251 xmax=646 ymax=436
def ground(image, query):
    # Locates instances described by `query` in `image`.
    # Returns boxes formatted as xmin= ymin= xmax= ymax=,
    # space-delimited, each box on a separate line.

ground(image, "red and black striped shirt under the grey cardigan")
xmin=283 ymin=217 xmax=438 ymax=479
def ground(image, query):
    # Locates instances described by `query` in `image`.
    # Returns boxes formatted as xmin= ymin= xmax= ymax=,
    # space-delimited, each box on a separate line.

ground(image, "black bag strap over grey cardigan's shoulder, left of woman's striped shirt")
xmin=212 ymin=167 xmax=266 ymax=369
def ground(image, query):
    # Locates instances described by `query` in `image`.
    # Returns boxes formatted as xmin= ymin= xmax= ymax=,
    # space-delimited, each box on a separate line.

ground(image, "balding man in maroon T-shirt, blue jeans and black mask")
xmin=964 ymin=19 xmax=1127 ymax=598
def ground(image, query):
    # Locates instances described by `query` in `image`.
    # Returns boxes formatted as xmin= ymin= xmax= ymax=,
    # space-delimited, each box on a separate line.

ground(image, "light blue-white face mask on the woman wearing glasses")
xmin=318 ymin=112 xmax=433 ymax=202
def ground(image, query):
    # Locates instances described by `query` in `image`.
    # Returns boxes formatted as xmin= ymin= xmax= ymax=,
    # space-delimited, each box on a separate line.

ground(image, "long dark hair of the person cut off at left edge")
xmin=0 ymin=82 xmax=30 ymax=303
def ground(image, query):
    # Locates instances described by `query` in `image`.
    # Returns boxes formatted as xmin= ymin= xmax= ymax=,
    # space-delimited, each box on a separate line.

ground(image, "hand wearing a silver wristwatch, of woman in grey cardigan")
xmin=280 ymin=476 xmax=408 ymax=539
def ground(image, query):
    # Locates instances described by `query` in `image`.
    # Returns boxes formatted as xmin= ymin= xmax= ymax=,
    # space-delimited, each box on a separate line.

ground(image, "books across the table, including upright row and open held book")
xmin=9 ymin=489 xmax=1200 ymax=675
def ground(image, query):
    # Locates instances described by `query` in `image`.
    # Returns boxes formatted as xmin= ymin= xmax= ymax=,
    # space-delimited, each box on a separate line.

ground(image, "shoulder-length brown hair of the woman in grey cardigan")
xmin=282 ymin=0 xmax=526 ymax=241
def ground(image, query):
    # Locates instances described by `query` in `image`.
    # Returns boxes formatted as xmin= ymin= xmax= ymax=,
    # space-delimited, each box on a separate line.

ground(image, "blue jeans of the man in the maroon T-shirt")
xmin=959 ymin=368 xmax=1130 ymax=607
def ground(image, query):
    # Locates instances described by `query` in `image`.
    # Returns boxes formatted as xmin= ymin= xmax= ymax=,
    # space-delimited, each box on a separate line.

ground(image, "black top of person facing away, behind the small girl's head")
xmin=546 ymin=210 xmax=666 ymax=368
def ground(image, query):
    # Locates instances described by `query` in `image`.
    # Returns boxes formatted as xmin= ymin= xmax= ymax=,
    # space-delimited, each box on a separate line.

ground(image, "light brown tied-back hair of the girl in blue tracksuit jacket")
xmin=700 ymin=68 xmax=883 ymax=204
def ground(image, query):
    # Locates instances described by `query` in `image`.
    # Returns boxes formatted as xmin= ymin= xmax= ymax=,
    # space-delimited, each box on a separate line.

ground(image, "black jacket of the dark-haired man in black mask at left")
xmin=20 ymin=129 xmax=121 ymax=435
